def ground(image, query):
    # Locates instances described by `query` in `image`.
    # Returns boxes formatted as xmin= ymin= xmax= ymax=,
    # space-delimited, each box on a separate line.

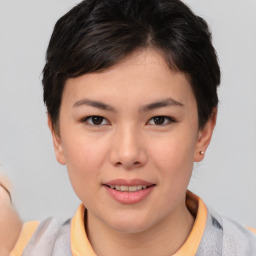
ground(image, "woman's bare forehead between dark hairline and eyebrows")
xmin=62 ymin=50 xmax=194 ymax=109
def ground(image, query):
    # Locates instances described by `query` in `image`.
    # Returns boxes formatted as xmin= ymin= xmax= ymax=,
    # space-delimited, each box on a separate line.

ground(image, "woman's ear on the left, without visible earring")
xmin=47 ymin=114 xmax=66 ymax=165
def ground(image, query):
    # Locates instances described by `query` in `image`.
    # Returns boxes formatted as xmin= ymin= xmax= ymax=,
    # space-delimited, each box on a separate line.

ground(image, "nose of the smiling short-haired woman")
xmin=110 ymin=125 xmax=147 ymax=169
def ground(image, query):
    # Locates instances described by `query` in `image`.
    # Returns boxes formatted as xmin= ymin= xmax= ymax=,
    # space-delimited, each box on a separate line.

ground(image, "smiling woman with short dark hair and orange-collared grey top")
xmin=3 ymin=0 xmax=256 ymax=255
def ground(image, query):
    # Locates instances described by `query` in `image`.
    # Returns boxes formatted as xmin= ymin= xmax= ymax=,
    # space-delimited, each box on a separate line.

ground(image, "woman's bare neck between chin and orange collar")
xmin=87 ymin=202 xmax=194 ymax=256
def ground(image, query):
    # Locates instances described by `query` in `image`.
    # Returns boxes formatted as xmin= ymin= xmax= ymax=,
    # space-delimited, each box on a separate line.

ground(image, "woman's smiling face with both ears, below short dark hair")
xmin=53 ymin=50 xmax=214 ymax=233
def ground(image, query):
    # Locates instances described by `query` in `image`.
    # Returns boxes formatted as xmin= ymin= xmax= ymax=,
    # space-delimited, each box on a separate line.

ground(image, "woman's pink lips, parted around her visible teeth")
xmin=103 ymin=179 xmax=155 ymax=204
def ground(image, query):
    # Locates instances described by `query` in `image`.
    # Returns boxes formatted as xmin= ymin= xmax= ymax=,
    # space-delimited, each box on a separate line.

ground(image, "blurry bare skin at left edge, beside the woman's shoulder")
xmin=0 ymin=179 xmax=22 ymax=256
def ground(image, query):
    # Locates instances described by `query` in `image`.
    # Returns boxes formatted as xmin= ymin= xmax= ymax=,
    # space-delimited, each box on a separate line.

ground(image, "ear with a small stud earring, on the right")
xmin=194 ymin=108 xmax=217 ymax=162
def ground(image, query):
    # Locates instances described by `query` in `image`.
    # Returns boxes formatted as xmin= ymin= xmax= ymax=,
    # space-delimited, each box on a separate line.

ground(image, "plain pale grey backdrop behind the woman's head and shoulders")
xmin=0 ymin=0 xmax=256 ymax=227
